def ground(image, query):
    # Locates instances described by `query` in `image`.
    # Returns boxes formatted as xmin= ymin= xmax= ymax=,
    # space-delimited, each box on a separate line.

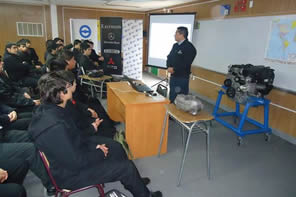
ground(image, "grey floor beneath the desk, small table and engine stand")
xmin=25 ymin=72 xmax=296 ymax=197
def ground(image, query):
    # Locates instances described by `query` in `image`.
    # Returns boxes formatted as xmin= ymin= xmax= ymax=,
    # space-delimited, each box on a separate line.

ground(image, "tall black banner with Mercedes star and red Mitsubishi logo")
xmin=100 ymin=17 xmax=122 ymax=75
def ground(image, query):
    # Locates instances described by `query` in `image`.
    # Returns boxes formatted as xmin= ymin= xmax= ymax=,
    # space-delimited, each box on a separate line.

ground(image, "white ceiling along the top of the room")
xmin=0 ymin=0 xmax=201 ymax=11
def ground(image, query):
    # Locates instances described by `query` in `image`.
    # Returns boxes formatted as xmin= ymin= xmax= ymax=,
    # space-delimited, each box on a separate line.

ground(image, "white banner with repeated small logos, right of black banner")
xmin=122 ymin=19 xmax=143 ymax=80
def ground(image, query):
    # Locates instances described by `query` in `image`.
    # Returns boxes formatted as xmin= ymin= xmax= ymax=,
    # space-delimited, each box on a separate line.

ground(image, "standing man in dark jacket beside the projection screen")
xmin=167 ymin=27 xmax=196 ymax=103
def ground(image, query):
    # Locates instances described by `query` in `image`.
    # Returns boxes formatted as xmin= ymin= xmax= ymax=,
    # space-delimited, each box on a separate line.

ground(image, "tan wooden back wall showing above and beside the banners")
xmin=57 ymin=6 xmax=147 ymax=62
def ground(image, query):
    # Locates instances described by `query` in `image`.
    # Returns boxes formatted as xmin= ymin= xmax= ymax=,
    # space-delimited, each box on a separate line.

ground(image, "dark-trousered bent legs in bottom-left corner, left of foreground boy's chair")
xmin=0 ymin=130 xmax=55 ymax=196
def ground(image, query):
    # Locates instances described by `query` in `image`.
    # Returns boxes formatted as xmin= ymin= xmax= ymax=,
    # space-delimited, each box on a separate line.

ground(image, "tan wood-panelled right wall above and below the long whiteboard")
xmin=149 ymin=0 xmax=296 ymax=138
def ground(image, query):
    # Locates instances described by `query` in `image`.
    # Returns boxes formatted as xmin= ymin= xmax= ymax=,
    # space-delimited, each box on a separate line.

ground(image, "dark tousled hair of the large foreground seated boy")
xmin=38 ymin=72 xmax=69 ymax=105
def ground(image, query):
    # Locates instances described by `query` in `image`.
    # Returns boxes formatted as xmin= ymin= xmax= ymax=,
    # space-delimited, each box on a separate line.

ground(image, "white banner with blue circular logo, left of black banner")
xmin=70 ymin=19 xmax=101 ymax=52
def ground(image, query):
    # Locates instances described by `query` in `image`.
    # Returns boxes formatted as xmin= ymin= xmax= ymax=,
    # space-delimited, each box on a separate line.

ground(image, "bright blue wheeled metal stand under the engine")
xmin=213 ymin=87 xmax=271 ymax=145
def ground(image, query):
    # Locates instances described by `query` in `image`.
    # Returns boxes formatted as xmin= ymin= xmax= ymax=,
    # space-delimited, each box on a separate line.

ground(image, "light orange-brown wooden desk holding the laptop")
xmin=107 ymin=82 xmax=169 ymax=159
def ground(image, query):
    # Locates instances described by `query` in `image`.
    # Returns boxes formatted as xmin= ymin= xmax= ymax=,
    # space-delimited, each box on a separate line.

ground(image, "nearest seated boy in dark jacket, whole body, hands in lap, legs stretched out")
xmin=29 ymin=73 xmax=162 ymax=197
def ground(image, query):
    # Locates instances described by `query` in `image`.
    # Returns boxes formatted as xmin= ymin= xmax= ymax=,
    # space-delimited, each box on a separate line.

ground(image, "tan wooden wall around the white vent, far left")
xmin=0 ymin=3 xmax=51 ymax=61
